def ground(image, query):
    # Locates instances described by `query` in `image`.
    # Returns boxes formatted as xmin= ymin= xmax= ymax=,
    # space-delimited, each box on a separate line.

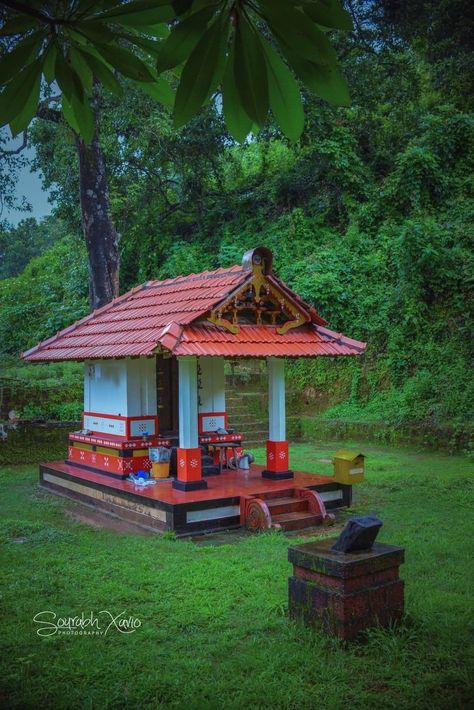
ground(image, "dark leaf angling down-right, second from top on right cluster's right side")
xmin=261 ymin=0 xmax=337 ymax=65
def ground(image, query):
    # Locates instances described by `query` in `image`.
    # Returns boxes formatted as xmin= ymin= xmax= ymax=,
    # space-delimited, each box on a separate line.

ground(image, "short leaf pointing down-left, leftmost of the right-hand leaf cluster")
xmin=156 ymin=6 xmax=214 ymax=72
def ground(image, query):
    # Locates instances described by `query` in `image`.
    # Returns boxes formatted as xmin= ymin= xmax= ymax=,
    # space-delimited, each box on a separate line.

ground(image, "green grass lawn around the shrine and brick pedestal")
xmin=0 ymin=444 xmax=474 ymax=710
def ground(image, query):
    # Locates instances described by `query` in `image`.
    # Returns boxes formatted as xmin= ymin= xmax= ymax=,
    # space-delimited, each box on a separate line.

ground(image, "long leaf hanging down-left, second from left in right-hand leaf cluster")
xmin=174 ymin=17 xmax=227 ymax=127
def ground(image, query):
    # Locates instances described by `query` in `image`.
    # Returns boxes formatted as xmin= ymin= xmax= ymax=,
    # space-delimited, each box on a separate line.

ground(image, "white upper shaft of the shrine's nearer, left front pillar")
xmin=178 ymin=355 xmax=199 ymax=449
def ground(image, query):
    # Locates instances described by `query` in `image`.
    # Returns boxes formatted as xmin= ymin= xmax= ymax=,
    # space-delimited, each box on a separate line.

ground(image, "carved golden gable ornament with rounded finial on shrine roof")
xmin=207 ymin=247 xmax=311 ymax=335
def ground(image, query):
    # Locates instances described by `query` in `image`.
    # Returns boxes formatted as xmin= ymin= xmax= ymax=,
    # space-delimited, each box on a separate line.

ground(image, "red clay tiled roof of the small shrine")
xmin=23 ymin=266 xmax=365 ymax=362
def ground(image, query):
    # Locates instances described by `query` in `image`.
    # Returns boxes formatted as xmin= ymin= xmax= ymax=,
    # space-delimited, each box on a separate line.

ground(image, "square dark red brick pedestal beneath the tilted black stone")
xmin=288 ymin=539 xmax=404 ymax=640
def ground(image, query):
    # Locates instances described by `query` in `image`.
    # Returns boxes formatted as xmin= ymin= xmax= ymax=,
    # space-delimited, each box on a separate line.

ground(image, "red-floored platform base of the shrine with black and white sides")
xmin=40 ymin=461 xmax=351 ymax=534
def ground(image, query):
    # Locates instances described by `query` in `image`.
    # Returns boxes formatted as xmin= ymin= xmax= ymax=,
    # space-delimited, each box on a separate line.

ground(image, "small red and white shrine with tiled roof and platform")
xmin=22 ymin=247 xmax=365 ymax=534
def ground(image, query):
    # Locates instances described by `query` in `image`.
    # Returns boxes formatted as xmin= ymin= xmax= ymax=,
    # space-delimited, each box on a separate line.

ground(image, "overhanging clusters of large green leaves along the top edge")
xmin=0 ymin=0 xmax=352 ymax=142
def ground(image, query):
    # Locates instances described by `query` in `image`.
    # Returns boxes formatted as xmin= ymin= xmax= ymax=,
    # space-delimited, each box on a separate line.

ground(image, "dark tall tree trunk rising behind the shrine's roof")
xmin=76 ymin=129 xmax=120 ymax=310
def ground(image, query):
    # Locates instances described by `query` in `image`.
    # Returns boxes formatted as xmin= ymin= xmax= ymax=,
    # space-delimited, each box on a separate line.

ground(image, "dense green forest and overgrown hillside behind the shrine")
xmin=0 ymin=0 xmax=474 ymax=450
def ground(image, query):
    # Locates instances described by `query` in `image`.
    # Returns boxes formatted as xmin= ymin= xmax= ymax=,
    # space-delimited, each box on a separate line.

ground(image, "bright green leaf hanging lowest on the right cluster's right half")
xmin=262 ymin=40 xmax=304 ymax=141
